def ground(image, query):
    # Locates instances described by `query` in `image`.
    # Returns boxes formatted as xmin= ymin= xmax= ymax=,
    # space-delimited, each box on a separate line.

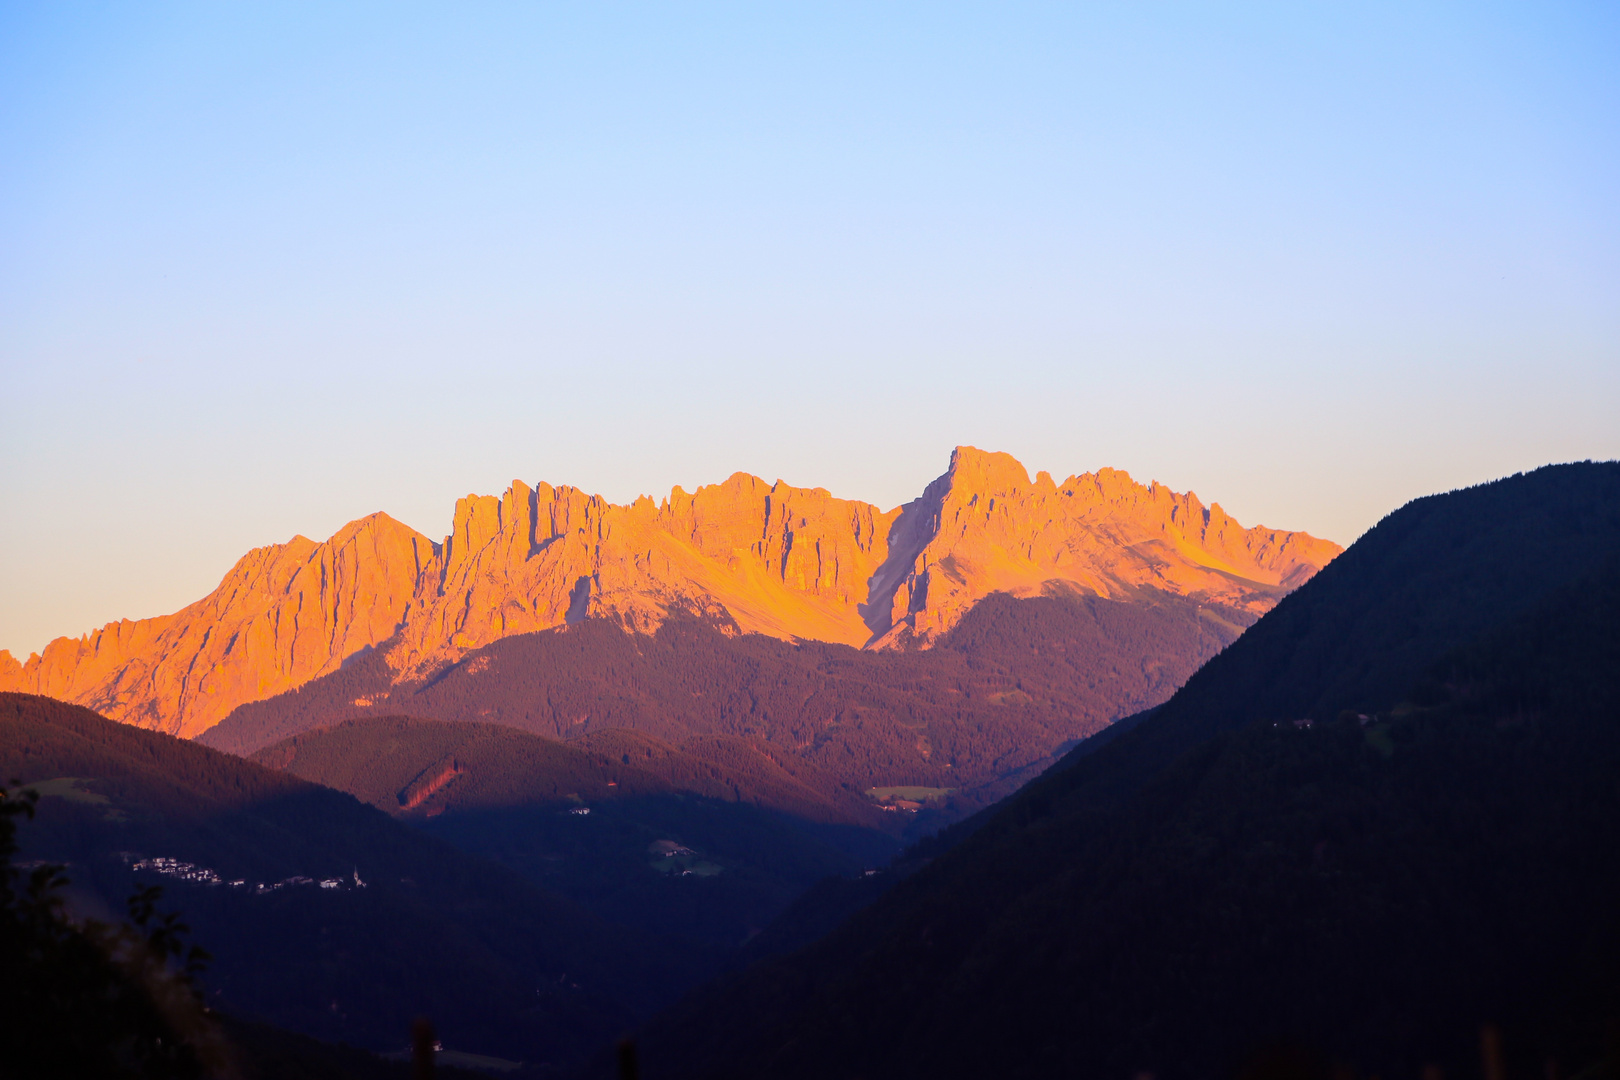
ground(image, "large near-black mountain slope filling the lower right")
xmin=628 ymin=465 xmax=1620 ymax=1080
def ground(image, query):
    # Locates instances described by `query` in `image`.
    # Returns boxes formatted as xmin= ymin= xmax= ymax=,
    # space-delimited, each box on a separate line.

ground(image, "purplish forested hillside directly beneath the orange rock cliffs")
xmin=199 ymin=589 xmax=1249 ymax=829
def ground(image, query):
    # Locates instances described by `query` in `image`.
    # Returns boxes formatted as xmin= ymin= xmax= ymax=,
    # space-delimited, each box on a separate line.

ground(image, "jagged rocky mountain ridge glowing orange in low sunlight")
xmin=0 ymin=447 xmax=1340 ymax=737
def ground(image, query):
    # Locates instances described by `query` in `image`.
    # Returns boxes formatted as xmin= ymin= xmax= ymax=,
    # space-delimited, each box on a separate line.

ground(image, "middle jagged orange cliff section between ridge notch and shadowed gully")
xmin=390 ymin=473 xmax=897 ymax=672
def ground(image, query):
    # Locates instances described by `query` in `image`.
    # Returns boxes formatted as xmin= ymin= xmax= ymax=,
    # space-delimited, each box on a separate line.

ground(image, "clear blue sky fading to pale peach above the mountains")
xmin=0 ymin=0 xmax=1620 ymax=656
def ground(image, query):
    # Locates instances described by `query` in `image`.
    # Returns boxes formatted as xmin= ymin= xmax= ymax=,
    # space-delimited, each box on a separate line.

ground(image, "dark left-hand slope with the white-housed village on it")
xmin=0 ymin=695 xmax=705 ymax=1062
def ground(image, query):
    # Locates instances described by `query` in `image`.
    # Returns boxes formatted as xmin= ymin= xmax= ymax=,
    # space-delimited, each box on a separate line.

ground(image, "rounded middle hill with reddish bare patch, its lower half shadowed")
xmin=254 ymin=717 xmax=899 ymax=947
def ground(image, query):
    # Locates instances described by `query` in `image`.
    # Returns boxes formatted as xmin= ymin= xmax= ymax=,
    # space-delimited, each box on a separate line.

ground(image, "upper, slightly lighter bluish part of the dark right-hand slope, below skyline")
xmin=1043 ymin=461 xmax=1620 ymax=809
